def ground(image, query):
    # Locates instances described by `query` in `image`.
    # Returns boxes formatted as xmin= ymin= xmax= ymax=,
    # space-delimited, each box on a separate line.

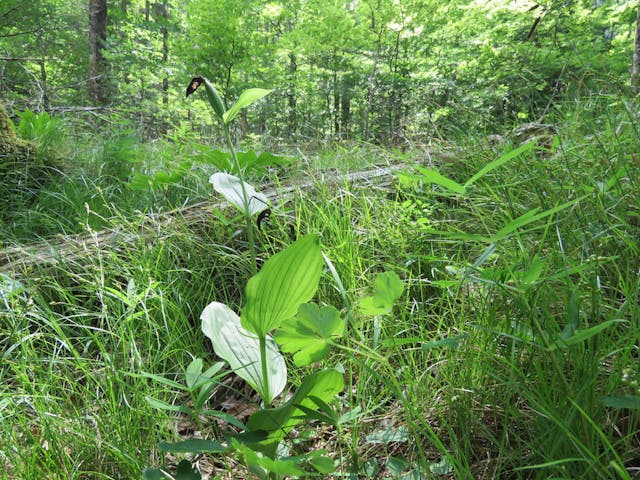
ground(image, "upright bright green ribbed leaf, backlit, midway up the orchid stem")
xmin=242 ymin=235 xmax=323 ymax=336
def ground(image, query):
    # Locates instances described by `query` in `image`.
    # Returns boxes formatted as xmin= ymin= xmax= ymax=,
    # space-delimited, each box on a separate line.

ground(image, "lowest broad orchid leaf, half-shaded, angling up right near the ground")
xmin=247 ymin=370 xmax=344 ymax=456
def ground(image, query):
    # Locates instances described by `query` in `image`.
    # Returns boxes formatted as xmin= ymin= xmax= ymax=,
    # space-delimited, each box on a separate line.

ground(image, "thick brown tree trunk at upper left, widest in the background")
xmin=89 ymin=0 xmax=107 ymax=105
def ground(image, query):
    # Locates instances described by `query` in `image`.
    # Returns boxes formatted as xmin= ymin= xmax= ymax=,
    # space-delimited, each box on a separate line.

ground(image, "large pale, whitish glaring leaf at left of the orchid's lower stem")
xmin=200 ymin=302 xmax=287 ymax=403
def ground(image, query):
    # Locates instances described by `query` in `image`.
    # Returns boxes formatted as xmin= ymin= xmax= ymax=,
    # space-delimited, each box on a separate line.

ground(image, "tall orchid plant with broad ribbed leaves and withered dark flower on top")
xmin=143 ymin=77 xmax=345 ymax=480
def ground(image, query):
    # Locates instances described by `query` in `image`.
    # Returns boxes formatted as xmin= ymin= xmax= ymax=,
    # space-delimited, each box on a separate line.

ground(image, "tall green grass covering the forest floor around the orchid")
xmin=0 ymin=95 xmax=640 ymax=479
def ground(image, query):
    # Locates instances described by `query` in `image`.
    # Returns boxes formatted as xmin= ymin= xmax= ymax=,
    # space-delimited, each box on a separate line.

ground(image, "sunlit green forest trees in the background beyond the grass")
xmin=0 ymin=0 xmax=637 ymax=145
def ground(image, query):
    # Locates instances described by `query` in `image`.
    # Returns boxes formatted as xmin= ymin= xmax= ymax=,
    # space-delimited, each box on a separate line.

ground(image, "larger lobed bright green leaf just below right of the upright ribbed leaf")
xmin=274 ymin=303 xmax=344 ymax=366
